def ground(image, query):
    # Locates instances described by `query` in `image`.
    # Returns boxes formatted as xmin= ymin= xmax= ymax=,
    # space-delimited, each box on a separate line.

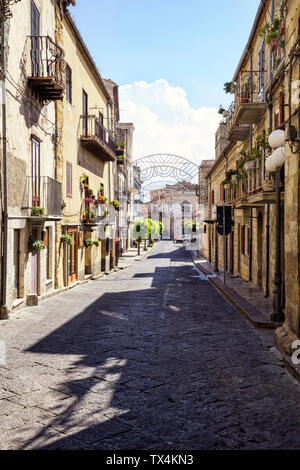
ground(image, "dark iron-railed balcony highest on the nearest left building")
xmin=27 ymin=36 xmax=65 ymax=101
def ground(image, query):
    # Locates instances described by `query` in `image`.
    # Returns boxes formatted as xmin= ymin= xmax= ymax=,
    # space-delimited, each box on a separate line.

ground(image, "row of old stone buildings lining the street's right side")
xmin=205 ymin=0 xmax=300 ymax=350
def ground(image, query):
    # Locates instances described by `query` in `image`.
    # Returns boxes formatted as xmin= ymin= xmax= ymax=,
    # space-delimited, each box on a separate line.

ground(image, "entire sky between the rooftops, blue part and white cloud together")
xmin=69 ymin=0 xmax=260 ymax=164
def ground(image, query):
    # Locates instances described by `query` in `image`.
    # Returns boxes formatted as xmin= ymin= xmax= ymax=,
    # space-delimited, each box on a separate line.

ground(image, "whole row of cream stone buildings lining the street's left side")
xmin=0 ymin=0 xmax=134 ymax=318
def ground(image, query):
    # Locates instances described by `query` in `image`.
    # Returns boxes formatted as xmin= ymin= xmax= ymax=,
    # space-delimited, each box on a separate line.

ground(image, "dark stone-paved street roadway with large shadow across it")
xmin=0 ymin=242 xmax=300 ymax=450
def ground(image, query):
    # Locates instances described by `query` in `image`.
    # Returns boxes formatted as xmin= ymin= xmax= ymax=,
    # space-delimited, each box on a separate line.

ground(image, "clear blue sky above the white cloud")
xmin=70 ymin=0 xmax=259 ymax=107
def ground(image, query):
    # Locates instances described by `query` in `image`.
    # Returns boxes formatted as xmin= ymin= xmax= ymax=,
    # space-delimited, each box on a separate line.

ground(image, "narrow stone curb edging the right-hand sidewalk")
xmin=192 ymin=255 xmax=282 ymax=330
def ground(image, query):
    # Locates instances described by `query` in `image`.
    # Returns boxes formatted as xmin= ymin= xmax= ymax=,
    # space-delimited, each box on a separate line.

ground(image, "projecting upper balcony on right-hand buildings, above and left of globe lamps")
xmin=233 ymin=71 xmax=266 ymax=126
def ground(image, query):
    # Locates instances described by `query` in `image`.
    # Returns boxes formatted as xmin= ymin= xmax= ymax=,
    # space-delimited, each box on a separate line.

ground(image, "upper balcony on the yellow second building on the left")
xmin=80 ymin=115 xmax=116 ymax=161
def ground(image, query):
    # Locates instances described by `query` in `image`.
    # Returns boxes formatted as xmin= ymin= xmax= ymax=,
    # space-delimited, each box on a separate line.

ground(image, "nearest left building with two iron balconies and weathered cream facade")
xmin=1 ymin=0 xmax=64 ymax=316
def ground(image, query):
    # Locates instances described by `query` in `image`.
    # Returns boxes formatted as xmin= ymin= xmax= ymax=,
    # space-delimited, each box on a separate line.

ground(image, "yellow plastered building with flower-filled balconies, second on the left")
xmin=57 ymin=4 xmax=116 ymax=287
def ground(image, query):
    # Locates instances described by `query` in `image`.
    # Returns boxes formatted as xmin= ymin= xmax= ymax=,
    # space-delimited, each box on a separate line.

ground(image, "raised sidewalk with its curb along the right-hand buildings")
xmin=192 ymin=253 xmax=283 ymax=330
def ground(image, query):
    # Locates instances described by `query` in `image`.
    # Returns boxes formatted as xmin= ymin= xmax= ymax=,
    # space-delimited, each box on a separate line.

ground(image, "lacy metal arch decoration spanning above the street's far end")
xmin=133 ymin=153 xmax=198 ymax=182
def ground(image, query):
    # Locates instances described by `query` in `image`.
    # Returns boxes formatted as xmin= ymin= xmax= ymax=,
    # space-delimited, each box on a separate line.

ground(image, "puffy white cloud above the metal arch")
xmin=119 ymin=79 xmax=220 ymax=164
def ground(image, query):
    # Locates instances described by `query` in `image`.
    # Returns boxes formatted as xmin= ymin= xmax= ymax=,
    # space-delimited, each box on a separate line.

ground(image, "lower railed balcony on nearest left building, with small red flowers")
xmin=22 ymin=176 xmax=62 ymax=221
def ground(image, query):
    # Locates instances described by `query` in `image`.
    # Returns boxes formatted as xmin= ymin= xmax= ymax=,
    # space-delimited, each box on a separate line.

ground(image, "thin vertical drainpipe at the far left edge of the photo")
xmin=0 ymin=19 xmax=8 ymax=319
